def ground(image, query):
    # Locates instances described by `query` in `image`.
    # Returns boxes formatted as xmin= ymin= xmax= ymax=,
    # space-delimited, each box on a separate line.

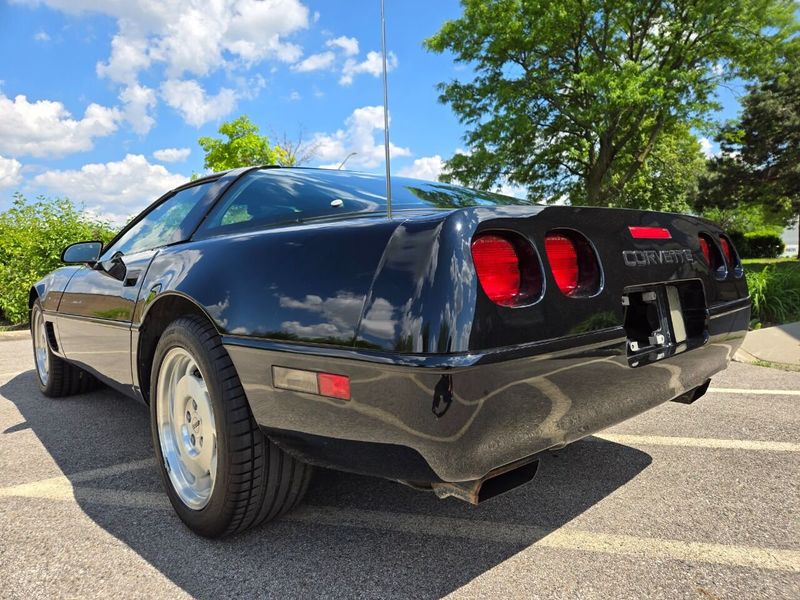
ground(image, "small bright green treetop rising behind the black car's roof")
xmin=197 ymin=115 xmax=298 ymax=171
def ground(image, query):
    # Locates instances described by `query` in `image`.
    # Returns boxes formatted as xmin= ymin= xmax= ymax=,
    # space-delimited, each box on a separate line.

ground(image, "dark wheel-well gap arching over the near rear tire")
xmin=136 ymin=294 xmax=216 ymax=404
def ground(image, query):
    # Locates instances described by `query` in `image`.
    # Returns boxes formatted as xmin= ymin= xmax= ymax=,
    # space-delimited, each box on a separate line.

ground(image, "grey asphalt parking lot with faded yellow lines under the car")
xmin=0 ymin=337 xmax=800 ymax=600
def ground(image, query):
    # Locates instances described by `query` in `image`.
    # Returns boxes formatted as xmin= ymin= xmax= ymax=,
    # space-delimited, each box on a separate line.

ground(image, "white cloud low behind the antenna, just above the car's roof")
xmin=310 ymin=106 xmax=411 ymax=168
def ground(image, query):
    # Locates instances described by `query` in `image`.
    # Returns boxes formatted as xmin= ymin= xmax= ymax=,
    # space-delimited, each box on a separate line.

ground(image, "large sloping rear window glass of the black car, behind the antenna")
xmin=199 ymin=169 xmax=526 ymax=236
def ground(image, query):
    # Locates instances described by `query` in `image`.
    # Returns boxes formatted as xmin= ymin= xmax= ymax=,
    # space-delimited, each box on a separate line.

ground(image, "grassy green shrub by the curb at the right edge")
xmin=747 ymin=264 xmax=800 ymax=325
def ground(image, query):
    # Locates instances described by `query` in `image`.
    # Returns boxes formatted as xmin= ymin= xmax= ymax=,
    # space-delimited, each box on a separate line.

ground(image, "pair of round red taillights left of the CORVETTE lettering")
xmin=472 ymin=229 xmax=601 ymax=307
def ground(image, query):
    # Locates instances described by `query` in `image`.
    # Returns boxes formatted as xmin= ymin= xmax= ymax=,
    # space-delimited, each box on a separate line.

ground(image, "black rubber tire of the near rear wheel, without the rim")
xmin=150 ymin=317 xmax=312 ymax=538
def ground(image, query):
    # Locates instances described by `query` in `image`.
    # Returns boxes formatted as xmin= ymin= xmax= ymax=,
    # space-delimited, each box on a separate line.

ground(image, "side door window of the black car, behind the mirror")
xmin=101 ymin=182 xmax=213 ymax=260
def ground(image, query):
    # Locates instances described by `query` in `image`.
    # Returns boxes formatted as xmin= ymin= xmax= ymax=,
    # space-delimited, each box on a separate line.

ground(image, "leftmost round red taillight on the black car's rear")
xmin=472 ymin=234 xmax=522 ymax=306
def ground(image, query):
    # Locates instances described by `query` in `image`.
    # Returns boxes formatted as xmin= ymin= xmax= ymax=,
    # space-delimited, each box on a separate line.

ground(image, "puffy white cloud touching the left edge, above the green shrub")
xmin=0 ymin=92 xmax=122 ymax=157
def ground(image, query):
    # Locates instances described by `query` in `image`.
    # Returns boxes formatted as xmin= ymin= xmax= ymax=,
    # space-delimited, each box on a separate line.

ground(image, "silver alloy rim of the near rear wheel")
xmin=155 ymin=347 xmax=217 ymax=510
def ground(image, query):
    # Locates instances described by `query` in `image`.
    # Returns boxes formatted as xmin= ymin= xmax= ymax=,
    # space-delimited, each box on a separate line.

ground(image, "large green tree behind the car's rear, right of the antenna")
xmin=426 ymin=0 xmax=795 ymax=205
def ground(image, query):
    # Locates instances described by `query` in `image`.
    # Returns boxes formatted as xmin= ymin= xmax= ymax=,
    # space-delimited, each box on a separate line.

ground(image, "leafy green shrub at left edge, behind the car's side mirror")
xmin=0 ymin=194 xmax=114 ymax=323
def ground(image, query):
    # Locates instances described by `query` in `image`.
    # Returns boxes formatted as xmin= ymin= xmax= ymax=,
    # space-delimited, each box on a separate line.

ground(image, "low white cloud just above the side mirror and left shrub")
xmin=31 ymin=154 xmax=188 ymax=221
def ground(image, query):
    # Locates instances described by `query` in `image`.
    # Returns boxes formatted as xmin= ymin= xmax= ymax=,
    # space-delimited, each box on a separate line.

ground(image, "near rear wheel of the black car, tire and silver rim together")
xmin=150 ymin=317 xmax=311 ymax=537
